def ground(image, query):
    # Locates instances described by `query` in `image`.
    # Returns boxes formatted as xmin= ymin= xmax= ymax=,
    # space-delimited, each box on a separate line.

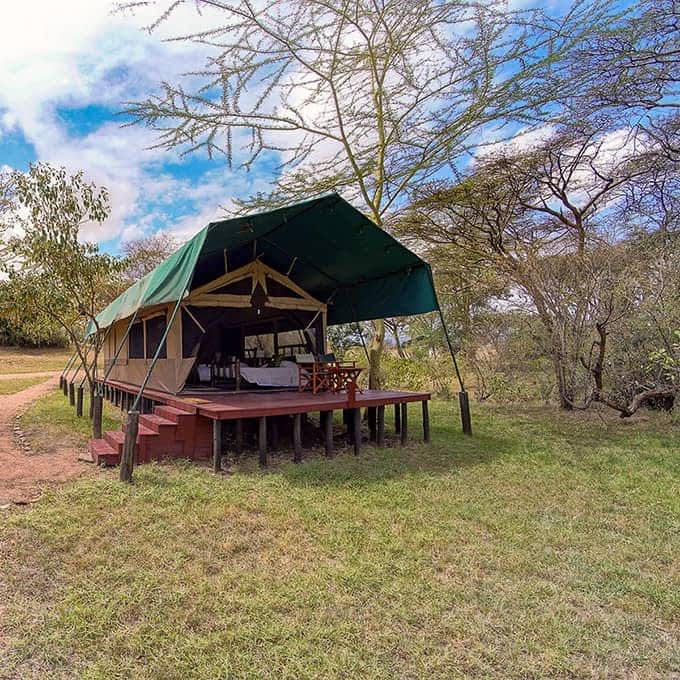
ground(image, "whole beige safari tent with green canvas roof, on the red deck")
xmin=89 ymin=194 xmax=438 ymax=395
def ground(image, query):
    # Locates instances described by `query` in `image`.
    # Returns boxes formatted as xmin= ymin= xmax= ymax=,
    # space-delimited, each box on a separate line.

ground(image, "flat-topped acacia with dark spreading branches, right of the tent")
xmin=401 ymin=131 xmax=649 ymax=409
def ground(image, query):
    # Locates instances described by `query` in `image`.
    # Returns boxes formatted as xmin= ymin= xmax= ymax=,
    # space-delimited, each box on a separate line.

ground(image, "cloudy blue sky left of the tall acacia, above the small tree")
xmin=0 ymin=0 xmax=274 ymax=252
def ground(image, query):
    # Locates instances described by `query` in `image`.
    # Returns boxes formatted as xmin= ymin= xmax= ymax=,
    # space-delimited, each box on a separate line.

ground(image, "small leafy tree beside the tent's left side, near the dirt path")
xmin=5 ymin=163 xmax=120 ymax=432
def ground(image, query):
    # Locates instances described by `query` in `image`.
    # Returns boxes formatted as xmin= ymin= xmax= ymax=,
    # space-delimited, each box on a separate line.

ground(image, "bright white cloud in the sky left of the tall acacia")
xmin=0 ymin=0 xmax=270 ymax=247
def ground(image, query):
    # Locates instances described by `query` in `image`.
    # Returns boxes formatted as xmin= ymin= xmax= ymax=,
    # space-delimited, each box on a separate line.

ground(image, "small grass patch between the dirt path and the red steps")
xmin=19 ymin=390 xmax=121 ymax=454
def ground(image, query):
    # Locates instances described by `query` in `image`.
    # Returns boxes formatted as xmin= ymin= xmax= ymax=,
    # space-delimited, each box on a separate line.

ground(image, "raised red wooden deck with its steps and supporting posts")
xmin=90 ymin=380 xmax=430 ymax=471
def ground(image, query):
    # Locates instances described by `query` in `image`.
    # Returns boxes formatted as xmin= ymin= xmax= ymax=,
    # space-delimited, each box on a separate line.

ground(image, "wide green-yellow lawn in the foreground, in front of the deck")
xmin=0 ymin=403 xmax=680 ymax=679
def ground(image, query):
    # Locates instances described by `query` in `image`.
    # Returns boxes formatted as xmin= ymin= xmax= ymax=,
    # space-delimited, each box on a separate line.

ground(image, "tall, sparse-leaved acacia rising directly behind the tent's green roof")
xmin=119 ymin=0 xmax=620 ymax=387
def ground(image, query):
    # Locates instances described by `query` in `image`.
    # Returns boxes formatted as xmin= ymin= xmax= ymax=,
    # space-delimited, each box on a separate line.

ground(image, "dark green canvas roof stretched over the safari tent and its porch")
xmin=90 ymin=194 xmax=438 ymax=328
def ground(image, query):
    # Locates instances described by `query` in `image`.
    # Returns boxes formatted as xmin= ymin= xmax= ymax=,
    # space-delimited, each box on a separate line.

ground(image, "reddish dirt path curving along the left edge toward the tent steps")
xmin=0 ymin=373 xmax=86 ymax=506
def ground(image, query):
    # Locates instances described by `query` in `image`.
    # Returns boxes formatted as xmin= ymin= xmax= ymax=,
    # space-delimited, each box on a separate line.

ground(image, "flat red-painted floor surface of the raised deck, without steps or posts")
xmin=101 ymin=380 xmax=430 ymax=420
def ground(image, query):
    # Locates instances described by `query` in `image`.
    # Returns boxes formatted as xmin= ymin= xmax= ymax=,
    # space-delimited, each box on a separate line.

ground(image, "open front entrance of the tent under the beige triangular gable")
xmin=182 ymin=260 xmax=327 ymax=390
